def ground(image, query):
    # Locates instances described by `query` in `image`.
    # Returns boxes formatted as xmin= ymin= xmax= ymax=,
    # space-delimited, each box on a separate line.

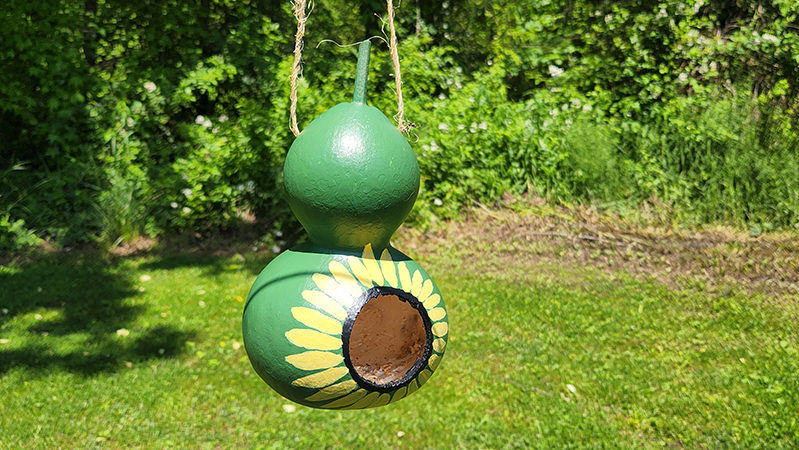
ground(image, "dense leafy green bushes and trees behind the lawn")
xmin=0 ymin=0 xmax=799 ymax=249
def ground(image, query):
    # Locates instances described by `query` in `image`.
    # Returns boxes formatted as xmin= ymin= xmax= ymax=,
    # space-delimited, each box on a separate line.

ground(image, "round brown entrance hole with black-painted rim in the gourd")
xmin=342 ymin=286 xmax=433 ymax=391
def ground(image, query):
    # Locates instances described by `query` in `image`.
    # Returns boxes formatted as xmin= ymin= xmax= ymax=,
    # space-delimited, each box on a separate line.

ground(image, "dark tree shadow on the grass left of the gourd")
xmin=0 ymin=258 xmax=195 ymax=377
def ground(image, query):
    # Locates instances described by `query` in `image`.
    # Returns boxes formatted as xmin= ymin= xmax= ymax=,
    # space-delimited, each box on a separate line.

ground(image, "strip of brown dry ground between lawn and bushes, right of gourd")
xmin=397 ymin=202 xmax=799 ymax=299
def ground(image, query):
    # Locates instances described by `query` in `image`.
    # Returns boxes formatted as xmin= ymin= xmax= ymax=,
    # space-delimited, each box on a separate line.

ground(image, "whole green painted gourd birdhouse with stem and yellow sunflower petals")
xmin=242 ymin=41 xmax=449 ymax=409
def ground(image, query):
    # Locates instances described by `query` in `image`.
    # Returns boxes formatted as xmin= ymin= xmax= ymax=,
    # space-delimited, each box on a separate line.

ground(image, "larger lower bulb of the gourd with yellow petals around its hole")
xmin=243 ymin=244 xmax=449 ymax=409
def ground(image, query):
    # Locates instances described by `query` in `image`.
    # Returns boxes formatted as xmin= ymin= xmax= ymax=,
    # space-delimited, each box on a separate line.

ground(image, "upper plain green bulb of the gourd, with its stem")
xmin=283 ymin=41 xmax=419 ymax=249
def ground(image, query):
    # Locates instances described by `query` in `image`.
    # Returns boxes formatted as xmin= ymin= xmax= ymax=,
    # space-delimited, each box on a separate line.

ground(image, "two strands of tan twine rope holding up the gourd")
xmin=289 ymin=0 xmax=414 ymax=136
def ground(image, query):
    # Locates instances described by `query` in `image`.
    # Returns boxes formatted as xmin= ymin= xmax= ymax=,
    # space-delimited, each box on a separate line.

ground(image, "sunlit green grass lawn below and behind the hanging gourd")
xmin=0 ymin=209 xmax=799 ymax=449
